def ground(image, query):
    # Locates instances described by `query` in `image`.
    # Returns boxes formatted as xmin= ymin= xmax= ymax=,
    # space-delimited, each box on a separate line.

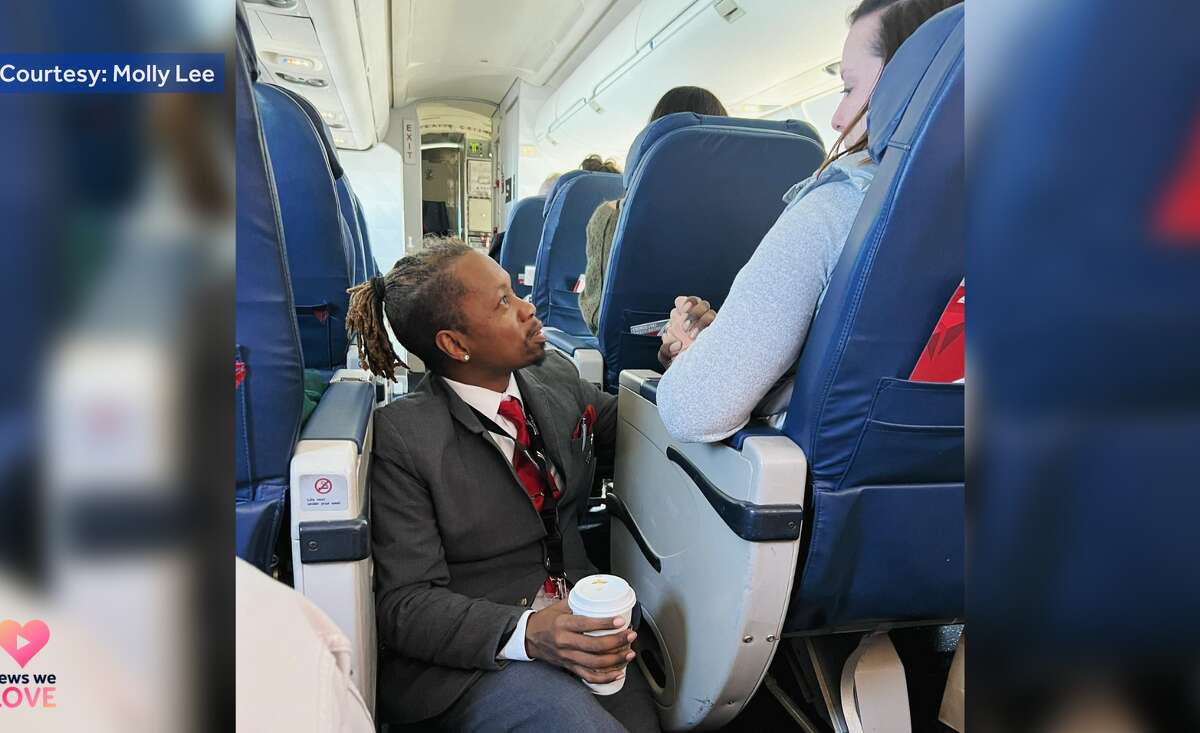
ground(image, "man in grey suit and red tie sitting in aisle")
xmin=347 ymin=240 xmax=659 ymax=731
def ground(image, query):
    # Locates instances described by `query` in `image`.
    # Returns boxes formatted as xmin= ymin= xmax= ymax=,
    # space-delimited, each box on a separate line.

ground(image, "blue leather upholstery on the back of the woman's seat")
xmin=784 ymin=6 xmax=966 ymax=631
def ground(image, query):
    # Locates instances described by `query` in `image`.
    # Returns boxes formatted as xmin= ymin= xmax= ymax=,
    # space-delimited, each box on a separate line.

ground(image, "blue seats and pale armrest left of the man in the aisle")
xmin=235 ymin=4 xmax=378 ymax=707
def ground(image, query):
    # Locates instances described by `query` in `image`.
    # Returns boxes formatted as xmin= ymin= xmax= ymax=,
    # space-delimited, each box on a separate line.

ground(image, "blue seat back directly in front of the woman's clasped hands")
xmin=598 ymin=112 xmax=826 ymax=385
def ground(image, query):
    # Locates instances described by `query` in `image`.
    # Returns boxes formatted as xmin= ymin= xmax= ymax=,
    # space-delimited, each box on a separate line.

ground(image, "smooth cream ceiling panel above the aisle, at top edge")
xmin=392 ymin=0 xmax=636 ymax=107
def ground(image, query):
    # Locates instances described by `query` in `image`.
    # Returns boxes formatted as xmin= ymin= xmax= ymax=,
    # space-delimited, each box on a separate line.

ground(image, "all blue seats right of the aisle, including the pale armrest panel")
xmin=511 ymin=6 xmax=965 ymax=729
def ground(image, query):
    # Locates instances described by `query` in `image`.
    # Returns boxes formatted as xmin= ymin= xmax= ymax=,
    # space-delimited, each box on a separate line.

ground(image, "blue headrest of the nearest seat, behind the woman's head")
xmin=866 ymin=4 xmax=962 ymax=161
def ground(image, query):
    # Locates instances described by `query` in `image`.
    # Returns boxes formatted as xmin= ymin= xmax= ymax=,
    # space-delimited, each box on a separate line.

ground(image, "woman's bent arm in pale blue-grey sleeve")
xmin=658 ymin=182 xmax=863 ymax=443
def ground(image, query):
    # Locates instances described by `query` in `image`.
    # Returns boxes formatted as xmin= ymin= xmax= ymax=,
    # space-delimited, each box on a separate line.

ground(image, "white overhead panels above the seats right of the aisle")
xmin=534 ymin=0 xmax=856 ymax=164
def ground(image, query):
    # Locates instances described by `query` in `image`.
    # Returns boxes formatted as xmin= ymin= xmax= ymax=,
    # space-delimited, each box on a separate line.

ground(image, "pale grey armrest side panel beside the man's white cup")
xmin=610 ymin=381 xmax=808 ymax=731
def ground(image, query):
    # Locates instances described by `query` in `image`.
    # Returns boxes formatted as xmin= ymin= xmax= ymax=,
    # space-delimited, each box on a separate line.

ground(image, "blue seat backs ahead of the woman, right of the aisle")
xmin=500 ymin=113 xmax=824 ymax=392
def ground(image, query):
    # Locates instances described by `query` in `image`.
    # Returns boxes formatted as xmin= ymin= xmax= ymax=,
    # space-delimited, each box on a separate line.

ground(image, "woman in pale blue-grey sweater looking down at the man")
xmin=658 ymin=0 xmax=961 ymax=443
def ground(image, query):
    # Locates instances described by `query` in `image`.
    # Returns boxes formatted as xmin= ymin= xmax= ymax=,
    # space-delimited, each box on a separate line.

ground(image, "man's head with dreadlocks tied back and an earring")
xmin=346 ymin=238 xmax=546 ymax=379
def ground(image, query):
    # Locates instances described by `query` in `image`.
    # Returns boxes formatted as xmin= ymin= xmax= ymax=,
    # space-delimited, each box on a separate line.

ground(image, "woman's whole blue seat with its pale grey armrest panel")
xmin=605 ymin=6 xmax=966 ymax=731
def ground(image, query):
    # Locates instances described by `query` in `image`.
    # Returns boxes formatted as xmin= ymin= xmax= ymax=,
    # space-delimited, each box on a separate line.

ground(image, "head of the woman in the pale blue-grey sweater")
xmin=826 ymin=0 xmax=962 ymax=164
